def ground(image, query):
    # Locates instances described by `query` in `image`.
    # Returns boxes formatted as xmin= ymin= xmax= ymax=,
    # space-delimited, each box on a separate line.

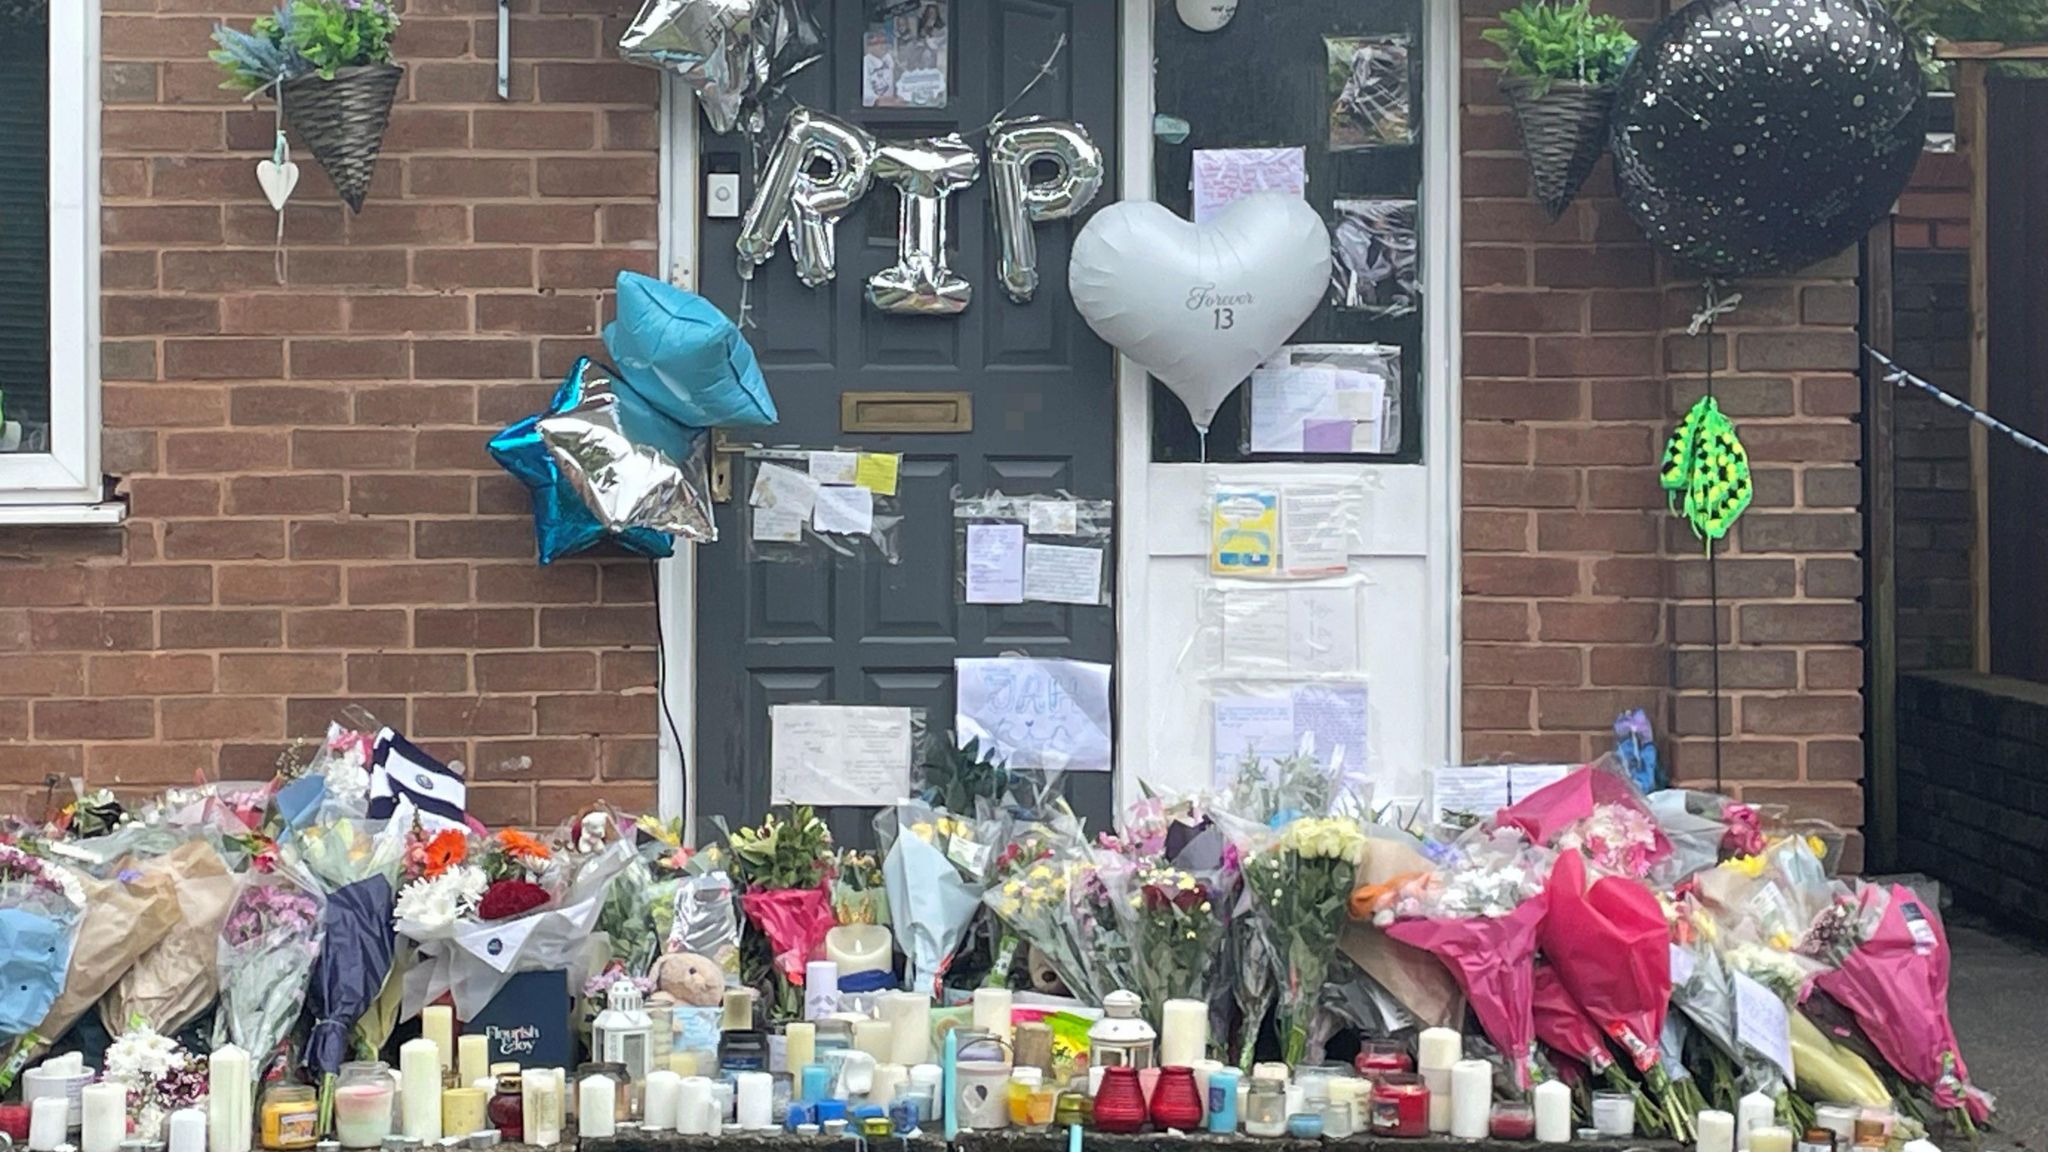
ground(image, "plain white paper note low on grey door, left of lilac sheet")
xmin=768 ymin=703 xmax=911 ymax=806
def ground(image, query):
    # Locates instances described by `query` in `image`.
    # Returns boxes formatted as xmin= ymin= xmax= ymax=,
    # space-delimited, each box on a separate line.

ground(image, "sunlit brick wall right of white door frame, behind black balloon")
xmin=1462 ymin=0 xmax=1864 ymax=865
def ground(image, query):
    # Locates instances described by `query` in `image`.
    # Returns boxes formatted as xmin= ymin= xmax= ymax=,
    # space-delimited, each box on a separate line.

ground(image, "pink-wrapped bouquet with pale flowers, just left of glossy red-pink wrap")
xmin=1374 ymin=830 xmax=1554 ymax=1088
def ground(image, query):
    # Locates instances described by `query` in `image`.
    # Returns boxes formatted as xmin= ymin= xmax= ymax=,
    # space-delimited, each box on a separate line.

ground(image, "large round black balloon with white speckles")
xmin=1614 ymin=0 xmax=1927 ymax=277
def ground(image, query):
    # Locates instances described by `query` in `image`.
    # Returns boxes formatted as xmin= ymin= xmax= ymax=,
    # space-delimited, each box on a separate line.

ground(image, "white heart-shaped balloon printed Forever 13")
xmin=1067 ymin=193 xmax=1329 ymax=433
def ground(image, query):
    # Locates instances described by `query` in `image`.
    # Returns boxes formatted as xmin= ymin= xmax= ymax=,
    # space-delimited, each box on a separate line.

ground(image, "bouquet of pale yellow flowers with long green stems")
xmin=1245 ymin=816 xmax=1366 ymax=1064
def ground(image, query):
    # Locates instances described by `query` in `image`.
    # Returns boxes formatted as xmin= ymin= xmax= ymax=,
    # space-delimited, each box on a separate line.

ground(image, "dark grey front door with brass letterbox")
xmin=696 ymin=0 xmax=1118 ymax=838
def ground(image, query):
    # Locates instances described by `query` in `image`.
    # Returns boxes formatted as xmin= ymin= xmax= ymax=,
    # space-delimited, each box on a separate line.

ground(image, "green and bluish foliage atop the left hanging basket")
xmin=207 ymin=0 xmax=399 ymax=92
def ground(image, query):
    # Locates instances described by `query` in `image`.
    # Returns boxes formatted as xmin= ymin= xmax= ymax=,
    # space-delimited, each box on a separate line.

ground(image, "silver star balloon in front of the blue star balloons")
xmin=539 ymin=392 xmax=719 ymax=543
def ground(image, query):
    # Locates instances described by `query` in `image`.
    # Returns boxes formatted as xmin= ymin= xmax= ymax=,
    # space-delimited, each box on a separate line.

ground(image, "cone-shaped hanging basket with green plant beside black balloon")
xmin=1481 ymin=0 xmax=1636 ymax=219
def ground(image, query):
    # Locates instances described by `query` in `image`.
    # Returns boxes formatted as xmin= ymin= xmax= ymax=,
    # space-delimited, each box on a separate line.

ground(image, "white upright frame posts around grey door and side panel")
xmin=659 ymin=0 xmax=1462 ymax=824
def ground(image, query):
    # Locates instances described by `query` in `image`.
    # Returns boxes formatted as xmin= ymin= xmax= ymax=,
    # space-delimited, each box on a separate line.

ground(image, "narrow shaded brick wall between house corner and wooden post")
xmin=1892 ymin=152 xmax=1976 ymax=672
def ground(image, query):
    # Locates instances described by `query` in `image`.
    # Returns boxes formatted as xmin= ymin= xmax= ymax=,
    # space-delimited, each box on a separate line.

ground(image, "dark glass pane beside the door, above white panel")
xmin=1151 ymin=0 xmax=1442 ymax=463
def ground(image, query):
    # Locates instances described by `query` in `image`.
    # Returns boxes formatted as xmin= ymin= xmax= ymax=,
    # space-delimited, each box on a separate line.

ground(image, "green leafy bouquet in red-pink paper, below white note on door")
xmin=725 ymin=804 xmax=836 ymax=1019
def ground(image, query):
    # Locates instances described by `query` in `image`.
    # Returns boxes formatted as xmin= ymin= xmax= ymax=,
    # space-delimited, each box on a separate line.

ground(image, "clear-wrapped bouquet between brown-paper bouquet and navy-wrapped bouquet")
xmin=213 ymin=863 xmax=324 ymax=1068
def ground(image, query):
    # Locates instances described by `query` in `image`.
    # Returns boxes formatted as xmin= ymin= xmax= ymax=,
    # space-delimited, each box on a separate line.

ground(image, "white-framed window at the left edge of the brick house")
xmin=0 ymin=0 xmax=102 ymax=523
